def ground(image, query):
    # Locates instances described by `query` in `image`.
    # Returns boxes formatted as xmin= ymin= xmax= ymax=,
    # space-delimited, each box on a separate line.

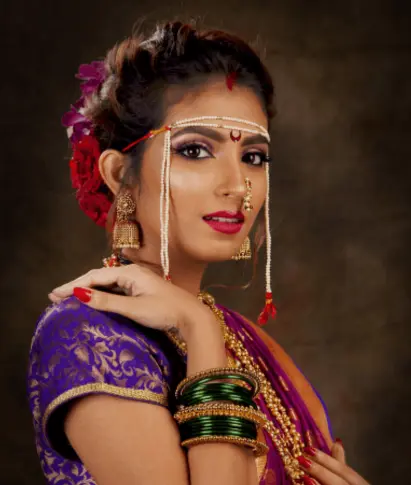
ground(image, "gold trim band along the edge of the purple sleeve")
xmin=42 ymin=382 xmax=168 ymax=438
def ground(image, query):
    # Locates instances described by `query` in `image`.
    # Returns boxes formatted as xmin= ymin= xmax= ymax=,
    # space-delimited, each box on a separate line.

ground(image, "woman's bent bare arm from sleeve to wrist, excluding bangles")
xmin=65 ymin=310 xmax=257 ymax=485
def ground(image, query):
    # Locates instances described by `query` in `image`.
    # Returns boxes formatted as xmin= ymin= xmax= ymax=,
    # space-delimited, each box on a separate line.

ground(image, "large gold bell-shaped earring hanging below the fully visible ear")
xmin=113 ymin=192 xmax=140 ymax=249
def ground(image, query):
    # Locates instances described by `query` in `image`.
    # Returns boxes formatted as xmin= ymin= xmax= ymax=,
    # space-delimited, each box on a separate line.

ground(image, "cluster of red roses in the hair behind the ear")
xmin=70 ymin=135 xmax=111 ymax=227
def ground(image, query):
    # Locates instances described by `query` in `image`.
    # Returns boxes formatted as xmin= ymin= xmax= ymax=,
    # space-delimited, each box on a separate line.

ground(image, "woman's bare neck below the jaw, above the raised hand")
xmin=122 ymin=247 xmax=207 ymax=296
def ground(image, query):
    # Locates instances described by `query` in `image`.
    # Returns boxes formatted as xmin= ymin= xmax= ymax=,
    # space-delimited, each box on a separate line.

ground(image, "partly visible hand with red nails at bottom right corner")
xmin=298 ymin=441 xmax=370 ymax=485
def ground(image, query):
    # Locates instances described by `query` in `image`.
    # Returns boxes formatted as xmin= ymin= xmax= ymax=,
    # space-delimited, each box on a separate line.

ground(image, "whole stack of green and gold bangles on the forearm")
xmin=174 ymin=367 xmax=268 ymax=456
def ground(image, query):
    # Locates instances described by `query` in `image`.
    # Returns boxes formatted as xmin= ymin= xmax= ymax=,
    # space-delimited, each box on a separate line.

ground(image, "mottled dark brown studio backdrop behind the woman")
xmin=0 ymin=0 xmax=411 ymax=485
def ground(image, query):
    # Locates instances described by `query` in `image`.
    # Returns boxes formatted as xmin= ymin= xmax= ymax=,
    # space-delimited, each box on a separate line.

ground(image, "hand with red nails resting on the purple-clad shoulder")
xmin=48 ymin=264 xmax=213 ymax=334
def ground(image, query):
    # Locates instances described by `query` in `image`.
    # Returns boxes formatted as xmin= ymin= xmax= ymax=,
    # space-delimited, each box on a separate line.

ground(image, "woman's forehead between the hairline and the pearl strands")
xmin=165 ymin=80 xmax=268 ymax=128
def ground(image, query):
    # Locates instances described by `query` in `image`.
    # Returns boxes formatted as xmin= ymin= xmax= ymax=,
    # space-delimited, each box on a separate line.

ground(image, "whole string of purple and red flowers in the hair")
xmin=61 ymin=61 xmax=112 ymax=227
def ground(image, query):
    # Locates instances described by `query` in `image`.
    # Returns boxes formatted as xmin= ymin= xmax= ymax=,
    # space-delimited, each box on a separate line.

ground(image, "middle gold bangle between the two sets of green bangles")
xmin=174 ymin=403 xmax=267 ymax=426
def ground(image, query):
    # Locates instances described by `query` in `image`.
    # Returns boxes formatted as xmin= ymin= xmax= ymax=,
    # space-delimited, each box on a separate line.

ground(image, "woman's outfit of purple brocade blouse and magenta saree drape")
xmin=28 ymin=297 xmax=330 ymax=485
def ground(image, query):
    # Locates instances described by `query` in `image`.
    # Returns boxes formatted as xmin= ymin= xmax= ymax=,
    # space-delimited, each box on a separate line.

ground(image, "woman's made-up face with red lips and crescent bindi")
xmin=134 ymin=81 xmax=269 ymax=262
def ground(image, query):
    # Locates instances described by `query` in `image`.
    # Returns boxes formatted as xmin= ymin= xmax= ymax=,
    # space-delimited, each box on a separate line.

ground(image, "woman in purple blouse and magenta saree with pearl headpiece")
xmin=29 ymin=22 xmax=372 ymax=485
